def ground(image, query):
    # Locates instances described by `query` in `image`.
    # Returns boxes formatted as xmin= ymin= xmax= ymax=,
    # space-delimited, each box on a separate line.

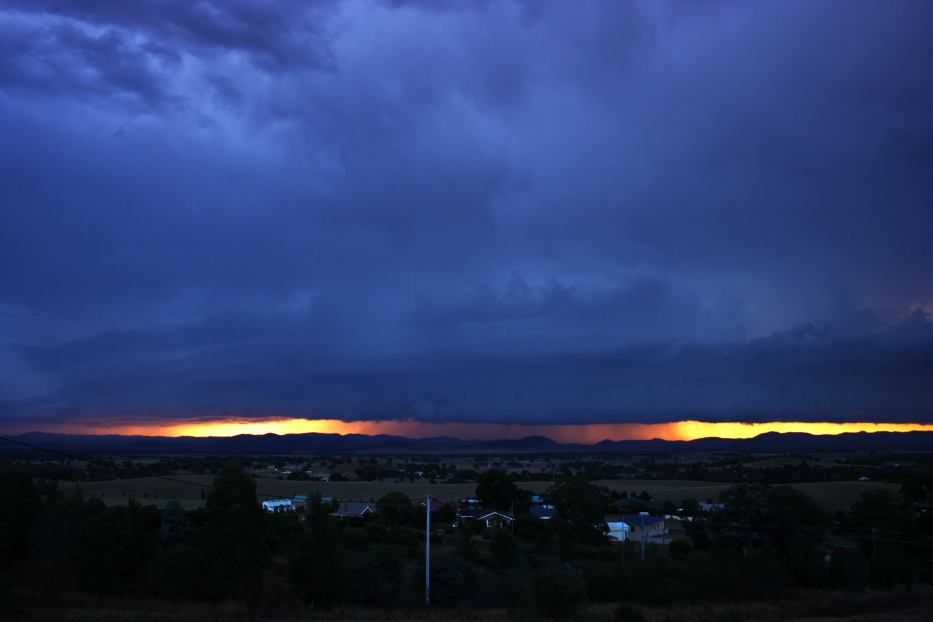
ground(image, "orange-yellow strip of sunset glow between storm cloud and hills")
xmin=18 ymin=418 xmax=933 ymax=444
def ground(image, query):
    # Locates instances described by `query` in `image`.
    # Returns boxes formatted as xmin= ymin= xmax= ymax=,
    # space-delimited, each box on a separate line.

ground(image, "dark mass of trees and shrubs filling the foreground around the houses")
xmin=0 ymin=462 xmax=933 ymax=621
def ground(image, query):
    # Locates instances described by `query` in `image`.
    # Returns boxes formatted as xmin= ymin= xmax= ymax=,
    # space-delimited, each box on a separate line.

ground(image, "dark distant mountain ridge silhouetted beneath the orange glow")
xmin=7 ymin=432 xmax=933 ymax=455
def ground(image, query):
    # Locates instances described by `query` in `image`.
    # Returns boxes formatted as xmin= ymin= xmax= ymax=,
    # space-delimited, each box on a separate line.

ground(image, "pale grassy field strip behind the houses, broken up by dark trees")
xmin=62 ymin=475 xmax=897 ymax=512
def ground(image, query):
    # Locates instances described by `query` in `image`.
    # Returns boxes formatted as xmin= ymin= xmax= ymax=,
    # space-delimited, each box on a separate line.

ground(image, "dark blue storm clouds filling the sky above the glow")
xmin=0 ymin=0 xmax=933 ymax=428
